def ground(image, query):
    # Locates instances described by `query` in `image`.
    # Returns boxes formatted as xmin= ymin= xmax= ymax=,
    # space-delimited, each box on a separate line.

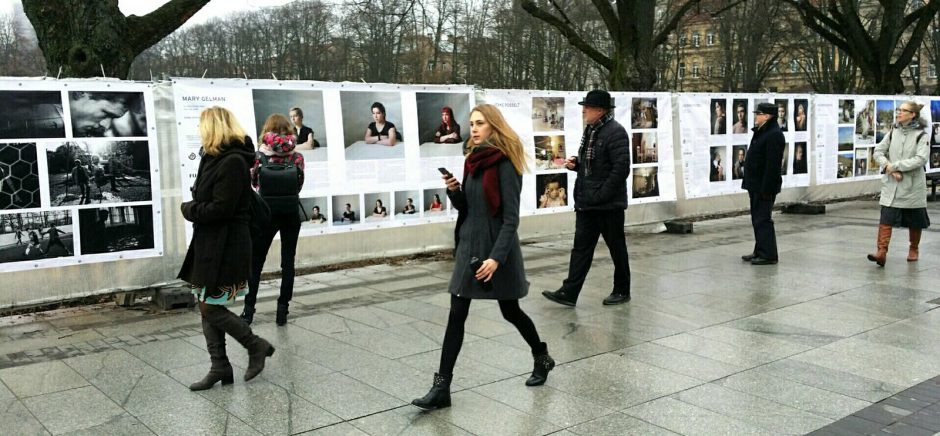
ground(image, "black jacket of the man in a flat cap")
xmin=741 ymin=118 xmax=786 ymax=195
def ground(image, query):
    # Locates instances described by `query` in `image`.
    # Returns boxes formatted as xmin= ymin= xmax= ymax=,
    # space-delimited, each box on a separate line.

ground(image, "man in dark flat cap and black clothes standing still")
xmin=741 ymin=103 xmax=786 ymax=265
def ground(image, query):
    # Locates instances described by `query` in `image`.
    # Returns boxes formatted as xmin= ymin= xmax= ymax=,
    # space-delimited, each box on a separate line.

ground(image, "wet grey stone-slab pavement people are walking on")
xmin=0 ymin=201 xmax=940 ymax=435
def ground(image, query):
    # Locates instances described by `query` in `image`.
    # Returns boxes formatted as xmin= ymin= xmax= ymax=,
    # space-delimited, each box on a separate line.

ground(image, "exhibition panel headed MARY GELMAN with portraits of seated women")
xmin=173 ymin=79 xmax=474 ymax=238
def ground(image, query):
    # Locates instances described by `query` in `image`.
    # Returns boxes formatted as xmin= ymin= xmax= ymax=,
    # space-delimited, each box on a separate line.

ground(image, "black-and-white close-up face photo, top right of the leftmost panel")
xmin=69 ymin=91 xmax=147 ymax=138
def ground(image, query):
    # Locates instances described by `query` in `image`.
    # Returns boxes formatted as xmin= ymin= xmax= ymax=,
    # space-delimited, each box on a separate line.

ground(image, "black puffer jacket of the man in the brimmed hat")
xmin=572 ymin=120 xmax=630 ymax=210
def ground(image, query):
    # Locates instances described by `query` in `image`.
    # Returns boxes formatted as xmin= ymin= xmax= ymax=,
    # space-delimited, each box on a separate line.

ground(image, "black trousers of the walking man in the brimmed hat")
xmin=561 ymin=209 xmax=630 ymax=300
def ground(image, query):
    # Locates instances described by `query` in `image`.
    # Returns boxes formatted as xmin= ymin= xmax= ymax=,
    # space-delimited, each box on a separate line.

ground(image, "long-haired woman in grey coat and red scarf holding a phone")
xmin=411 ymin=104 xmax=555 ymax=410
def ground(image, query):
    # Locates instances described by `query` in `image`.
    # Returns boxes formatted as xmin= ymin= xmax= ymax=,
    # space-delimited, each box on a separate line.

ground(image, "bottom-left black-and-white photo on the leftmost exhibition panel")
xmin=0 ymin=210 xmax=75 ymax=263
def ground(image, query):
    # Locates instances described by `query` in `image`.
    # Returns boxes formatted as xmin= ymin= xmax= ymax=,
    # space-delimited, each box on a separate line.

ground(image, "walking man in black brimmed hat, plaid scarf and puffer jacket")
xmin=542 ymin=90 xmax=630 ymax=306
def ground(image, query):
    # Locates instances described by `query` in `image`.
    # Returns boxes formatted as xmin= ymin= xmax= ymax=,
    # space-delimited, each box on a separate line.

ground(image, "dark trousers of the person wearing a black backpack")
xmin=245 ymin=213 xmax=300 ymax=310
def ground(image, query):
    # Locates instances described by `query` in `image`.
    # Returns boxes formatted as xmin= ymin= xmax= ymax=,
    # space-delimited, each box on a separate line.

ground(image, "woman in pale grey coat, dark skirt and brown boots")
xmin=868 ymin=101 xmax=930 ymax=266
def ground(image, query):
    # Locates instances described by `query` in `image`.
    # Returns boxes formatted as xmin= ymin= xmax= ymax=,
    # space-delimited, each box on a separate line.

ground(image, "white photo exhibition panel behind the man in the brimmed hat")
xmin=484 ymin=90 xmax=676 ymax=215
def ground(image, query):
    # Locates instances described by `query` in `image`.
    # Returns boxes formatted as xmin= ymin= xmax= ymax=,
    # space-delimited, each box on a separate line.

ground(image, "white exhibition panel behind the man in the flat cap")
xmin=678 ymin=94 xmax=812 ymax=198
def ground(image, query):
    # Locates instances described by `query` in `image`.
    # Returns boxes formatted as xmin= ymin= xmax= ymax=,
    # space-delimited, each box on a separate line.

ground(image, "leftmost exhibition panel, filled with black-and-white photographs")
xmin=0 ymin=80 xmax=163 ymax=272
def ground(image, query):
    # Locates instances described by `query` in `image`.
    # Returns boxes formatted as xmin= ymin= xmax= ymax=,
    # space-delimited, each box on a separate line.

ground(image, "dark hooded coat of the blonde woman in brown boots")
xmin=177 ymin=137 xmax=255 ymax=291
